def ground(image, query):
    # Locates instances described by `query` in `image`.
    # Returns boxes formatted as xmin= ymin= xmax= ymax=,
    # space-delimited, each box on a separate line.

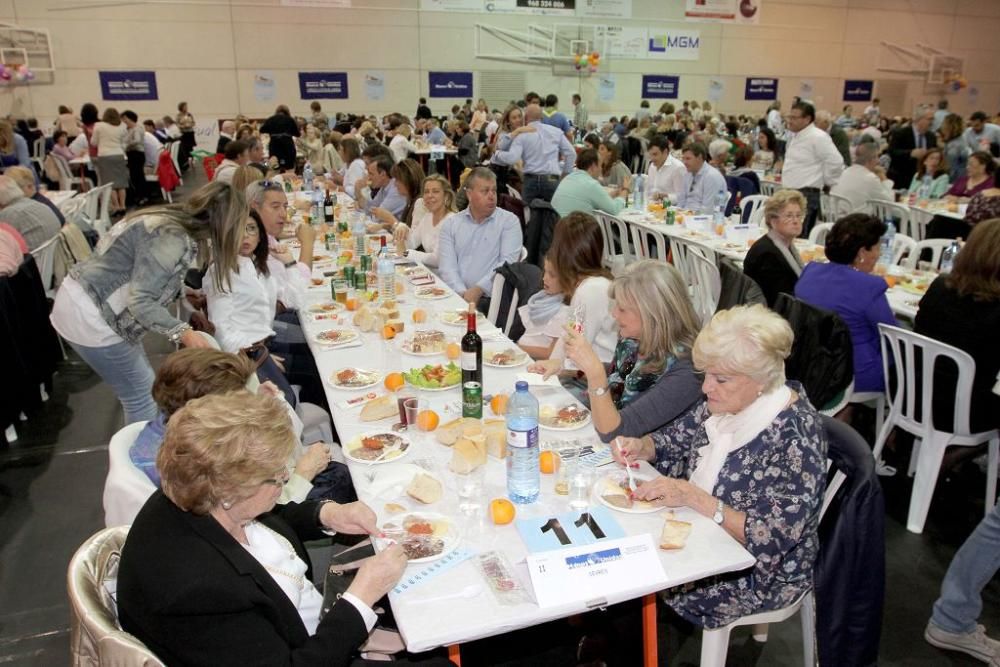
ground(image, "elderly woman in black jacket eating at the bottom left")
xmin=118 ymin=391 xmax=452 ymax=667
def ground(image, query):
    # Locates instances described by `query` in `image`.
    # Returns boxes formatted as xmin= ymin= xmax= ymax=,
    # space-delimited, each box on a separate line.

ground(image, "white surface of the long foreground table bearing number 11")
xmin=292 ymin=230 xmax=754 ymax=654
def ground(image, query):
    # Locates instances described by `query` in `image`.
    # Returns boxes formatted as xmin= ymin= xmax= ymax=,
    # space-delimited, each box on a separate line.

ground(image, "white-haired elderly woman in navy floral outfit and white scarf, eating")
xmin=612 ymin=305 xmax=827 ymax=628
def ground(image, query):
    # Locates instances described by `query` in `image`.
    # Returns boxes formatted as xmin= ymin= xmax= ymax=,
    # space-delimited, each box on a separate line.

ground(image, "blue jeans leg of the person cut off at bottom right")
xmin=931 ymin=504 xmax=1000 ymax=634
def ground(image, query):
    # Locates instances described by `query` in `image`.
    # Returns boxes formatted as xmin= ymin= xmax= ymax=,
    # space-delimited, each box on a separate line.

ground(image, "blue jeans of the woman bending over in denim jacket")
xmin=70 ymin=341 xmax=160 ymax=426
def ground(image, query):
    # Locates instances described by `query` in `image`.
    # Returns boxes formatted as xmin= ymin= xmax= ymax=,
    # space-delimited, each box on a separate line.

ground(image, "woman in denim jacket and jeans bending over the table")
xmin=51 ymin=183 xmax=248 ymax=424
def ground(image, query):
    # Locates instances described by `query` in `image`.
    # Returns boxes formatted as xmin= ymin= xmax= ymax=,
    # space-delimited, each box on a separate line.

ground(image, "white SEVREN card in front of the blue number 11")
xmin=527 ymin=533 xmax=667 ymax=608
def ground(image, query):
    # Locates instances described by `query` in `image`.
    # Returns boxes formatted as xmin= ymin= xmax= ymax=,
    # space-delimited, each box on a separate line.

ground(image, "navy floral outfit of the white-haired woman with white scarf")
xmin=651 ymin=383 xmax=827 ymax=628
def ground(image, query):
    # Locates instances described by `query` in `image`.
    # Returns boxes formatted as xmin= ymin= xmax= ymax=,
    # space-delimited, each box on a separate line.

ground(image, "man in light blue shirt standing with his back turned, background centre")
xmin=493 ymin=104 xmax=576 ymax=206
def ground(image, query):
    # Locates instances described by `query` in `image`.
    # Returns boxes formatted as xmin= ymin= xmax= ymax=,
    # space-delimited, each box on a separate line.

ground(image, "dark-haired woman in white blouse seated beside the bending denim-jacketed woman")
xmin=204 ymin=211 xmax=304 ymax=406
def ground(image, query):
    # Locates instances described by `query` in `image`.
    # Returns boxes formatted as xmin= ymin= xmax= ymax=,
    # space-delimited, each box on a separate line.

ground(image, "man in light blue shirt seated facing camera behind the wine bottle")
xmin=438 ymin=167 xmax=524 ymax=313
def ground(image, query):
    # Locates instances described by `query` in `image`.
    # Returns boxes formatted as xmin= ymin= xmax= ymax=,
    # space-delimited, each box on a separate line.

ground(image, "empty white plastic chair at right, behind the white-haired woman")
xmin=872 ymin=324 xmax=1000 ymax=533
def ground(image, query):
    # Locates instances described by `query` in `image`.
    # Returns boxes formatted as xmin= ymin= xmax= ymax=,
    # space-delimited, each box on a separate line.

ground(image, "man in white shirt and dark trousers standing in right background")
xmin=781 ymin=102 xmax=844 ymax=236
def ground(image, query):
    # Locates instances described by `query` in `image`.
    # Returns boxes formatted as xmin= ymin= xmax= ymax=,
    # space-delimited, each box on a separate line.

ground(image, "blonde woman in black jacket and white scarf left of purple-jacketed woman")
xmin=743 ymin=189 xmax=806 ymax=308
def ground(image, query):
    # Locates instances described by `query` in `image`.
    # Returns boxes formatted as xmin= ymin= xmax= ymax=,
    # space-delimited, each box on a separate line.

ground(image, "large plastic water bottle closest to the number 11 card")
xmin=507 ymin=381 xmax=540 ymax=505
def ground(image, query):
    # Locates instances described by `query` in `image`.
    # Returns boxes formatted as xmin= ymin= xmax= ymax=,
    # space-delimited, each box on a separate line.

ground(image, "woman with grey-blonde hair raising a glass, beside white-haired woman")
xmin=566 ymin=259 xmax=701 ymax=442
